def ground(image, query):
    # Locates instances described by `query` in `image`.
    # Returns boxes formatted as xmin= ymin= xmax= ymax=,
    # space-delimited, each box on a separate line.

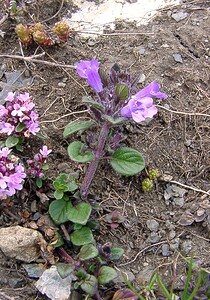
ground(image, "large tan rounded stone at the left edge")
xmin=0 ymin=226 xmax=45 ymax=263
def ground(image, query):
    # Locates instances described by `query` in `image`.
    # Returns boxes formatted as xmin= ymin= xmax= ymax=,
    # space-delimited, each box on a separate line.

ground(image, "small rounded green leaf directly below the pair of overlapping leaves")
xmin=71 ymin=226 xmax=94 ymax=246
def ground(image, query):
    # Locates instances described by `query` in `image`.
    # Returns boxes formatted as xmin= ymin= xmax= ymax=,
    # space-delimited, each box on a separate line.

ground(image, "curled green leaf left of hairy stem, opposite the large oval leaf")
xmin=68 ymin=141 xmax=94 ymax=162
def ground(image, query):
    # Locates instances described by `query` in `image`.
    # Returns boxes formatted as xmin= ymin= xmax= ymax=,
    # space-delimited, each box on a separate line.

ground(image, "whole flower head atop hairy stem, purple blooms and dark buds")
xmin=77 ymin=60 xmax=167 ymax=123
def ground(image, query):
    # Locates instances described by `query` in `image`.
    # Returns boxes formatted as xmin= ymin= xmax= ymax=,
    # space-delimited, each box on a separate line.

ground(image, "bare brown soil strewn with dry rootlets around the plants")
xmin=0 ymin=1 xmax=210 ymax=299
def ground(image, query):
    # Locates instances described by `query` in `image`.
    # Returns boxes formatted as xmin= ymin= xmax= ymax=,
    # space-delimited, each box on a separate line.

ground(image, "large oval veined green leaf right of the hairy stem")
xmin=110 ymin=147 xmax=145 ymax=176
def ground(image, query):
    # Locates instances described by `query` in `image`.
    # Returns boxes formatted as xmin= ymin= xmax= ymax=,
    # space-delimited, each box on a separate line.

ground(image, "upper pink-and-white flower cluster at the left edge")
xmin=0 ymin=92 xmax=40 ymax=137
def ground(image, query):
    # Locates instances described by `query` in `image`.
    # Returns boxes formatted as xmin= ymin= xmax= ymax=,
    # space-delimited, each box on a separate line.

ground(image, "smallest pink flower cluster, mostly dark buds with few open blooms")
xmin=26 ymin=146 xmax=52 ymax=178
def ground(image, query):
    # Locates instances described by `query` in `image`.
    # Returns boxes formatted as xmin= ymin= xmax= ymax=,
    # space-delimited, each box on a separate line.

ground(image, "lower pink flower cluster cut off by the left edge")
xmin=0 ymin=147 xmax=26 ymax=200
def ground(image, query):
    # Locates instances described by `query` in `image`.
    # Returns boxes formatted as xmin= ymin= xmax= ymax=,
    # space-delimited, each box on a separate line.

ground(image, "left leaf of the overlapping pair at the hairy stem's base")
xmin=49 ymin=199 xmax=72 ymax=225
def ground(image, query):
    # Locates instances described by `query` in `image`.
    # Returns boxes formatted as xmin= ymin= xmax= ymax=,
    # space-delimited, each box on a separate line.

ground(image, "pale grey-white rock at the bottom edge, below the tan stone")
xmin=35 ymin=266 xmax=72 ymax=300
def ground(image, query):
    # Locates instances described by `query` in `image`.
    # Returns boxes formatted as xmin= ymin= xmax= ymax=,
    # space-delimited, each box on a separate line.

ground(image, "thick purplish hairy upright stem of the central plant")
xmin=80 ymin=123 xmax=110 ymax=199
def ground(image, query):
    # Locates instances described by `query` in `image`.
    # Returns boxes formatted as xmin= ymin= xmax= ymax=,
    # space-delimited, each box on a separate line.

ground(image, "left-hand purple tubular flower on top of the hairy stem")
xmin=77 ymin=59 xmax=103 ymax=93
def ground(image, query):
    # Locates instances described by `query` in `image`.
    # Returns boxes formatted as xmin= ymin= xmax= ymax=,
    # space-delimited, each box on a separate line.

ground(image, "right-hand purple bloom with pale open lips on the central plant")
xmin=120 ymin=81 xmax=167 ymax=123
